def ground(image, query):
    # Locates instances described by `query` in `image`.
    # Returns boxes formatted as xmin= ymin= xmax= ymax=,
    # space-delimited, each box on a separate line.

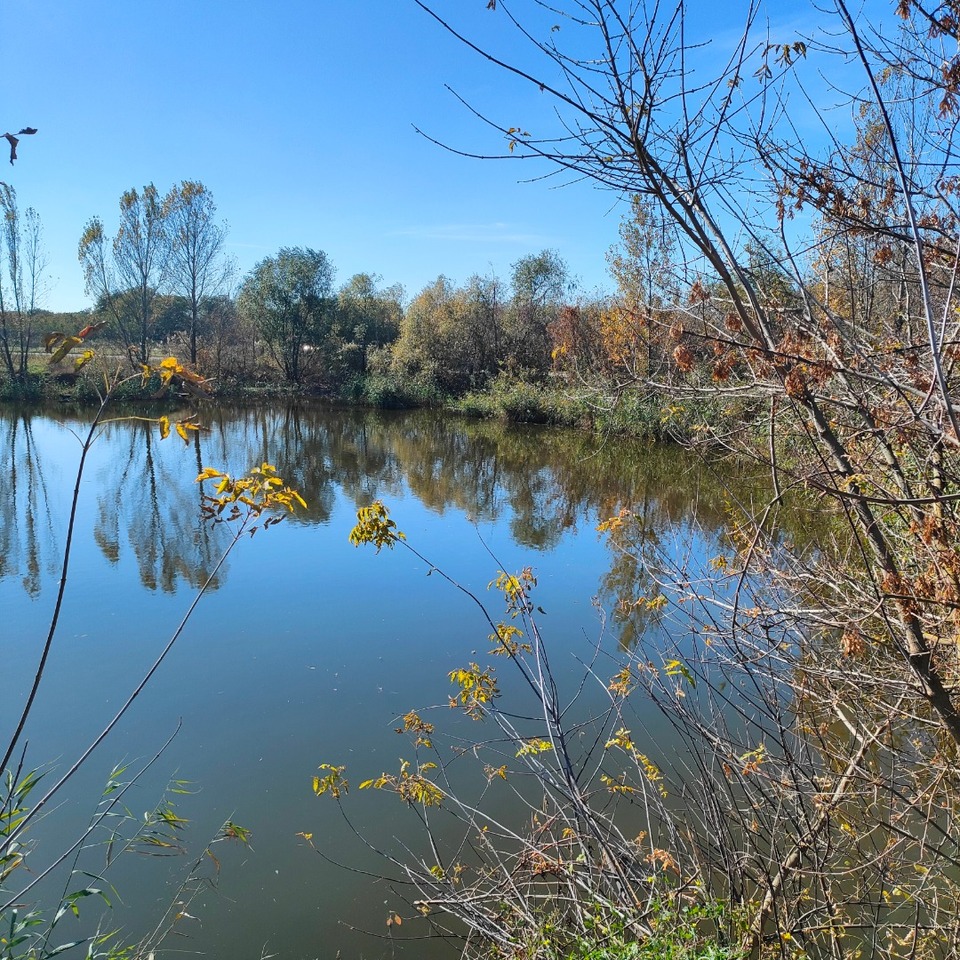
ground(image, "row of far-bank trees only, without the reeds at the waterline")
xmin=0 ymin=181 xmax=616 ymax=396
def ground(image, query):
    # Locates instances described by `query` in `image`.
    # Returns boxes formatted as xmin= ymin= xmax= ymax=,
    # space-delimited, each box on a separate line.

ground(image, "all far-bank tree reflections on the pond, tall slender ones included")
xmin=0 ymin=405 xmax=800 ymax=645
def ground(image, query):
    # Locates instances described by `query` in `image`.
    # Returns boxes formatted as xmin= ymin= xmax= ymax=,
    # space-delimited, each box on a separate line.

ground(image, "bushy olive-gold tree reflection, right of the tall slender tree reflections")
xmin=197 ymin=407 xmax=756 ymax=536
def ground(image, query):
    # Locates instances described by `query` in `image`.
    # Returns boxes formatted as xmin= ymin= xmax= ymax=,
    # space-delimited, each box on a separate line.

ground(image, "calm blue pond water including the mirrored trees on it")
xmin=0 ymin=407 xmax=756 ymax=960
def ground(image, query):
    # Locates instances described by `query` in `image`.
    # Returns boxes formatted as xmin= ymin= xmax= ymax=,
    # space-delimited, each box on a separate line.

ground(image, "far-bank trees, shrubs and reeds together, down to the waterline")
xmin=0 ymin=176 xmax=742 ymax=439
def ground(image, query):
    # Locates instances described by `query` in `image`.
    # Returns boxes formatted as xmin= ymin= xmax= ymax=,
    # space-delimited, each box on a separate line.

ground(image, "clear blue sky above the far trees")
xmin=0 ymin=0 xmax=856 ymax=310
